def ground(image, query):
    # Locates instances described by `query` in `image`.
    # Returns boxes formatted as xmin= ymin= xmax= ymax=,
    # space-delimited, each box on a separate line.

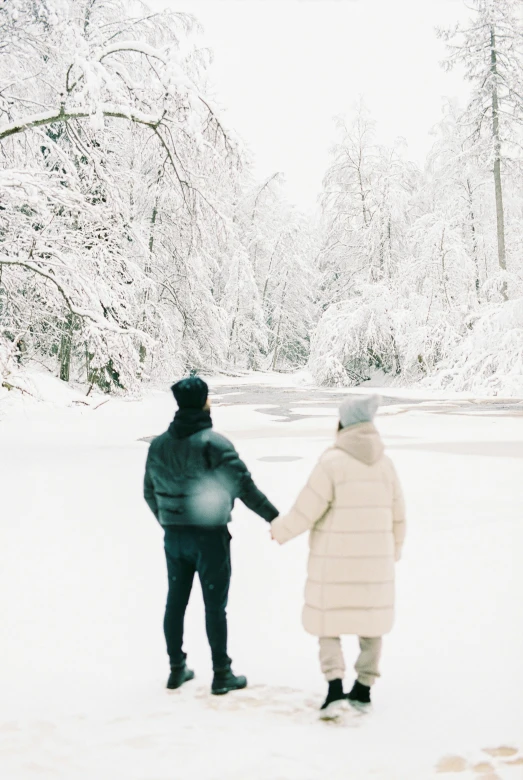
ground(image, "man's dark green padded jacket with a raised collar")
xmin=144 ymin=410 xmax=278 ymax=527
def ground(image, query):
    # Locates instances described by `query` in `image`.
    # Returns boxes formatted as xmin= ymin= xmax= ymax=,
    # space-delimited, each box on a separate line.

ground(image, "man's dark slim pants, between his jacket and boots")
xmin=164 ymin=526 xmax=231 ymax=671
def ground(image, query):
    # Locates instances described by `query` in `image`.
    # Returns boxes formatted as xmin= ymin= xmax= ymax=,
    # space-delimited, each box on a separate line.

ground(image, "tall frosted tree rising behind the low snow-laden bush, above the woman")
xmin=321 ymin=103 xmax=416 ymax=304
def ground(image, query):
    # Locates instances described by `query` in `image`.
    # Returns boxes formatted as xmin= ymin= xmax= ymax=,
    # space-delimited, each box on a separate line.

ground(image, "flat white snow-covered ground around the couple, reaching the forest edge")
xmin=0 ymin=378 xmax=523 ymax=780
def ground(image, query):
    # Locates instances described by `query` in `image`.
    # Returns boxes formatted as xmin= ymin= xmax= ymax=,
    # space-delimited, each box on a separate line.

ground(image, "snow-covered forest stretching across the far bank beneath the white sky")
xmin=0 ymin=0 xmax=523 ymax=395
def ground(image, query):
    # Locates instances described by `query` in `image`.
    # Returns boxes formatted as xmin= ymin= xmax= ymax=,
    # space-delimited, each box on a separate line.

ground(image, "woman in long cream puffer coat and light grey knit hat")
xmin=271 ymin=395 xmax=405 ymax=718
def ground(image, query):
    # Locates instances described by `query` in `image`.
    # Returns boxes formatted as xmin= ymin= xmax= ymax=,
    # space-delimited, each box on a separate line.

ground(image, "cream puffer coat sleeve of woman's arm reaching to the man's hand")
xmin=271 ymin=460 xmax=334 ymax=544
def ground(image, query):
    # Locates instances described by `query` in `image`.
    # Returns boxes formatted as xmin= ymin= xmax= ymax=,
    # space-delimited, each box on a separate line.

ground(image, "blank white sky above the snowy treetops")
xmin=149 ymin=0 xmax=470 ymax=208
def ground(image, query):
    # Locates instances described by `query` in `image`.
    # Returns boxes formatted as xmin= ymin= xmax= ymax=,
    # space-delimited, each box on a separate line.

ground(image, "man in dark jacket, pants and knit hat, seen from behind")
xmin=144 ymin=377 xmax=278 ymax=695
